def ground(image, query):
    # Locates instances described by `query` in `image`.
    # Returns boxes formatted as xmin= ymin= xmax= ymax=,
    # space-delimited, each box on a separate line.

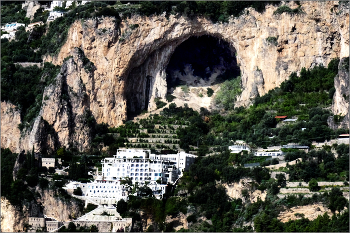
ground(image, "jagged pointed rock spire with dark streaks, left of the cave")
xmin=40 ymin=49 xmax=94 ymax=151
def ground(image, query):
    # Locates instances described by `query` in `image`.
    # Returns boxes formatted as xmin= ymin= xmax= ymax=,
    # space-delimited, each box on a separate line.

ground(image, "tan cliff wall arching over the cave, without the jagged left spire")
xmin=45 ymin=2 xmax=349 ymax=126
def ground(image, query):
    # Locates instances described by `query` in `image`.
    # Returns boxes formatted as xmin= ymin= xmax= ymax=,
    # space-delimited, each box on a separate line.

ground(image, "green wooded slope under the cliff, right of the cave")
xmin=174 ymin=59 xmax=347 ymax=149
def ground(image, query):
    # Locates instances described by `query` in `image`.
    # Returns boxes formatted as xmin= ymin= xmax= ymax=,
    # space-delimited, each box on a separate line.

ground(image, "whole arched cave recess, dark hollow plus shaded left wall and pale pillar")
xmin=125 ymin=34 xmax=241 ymax=120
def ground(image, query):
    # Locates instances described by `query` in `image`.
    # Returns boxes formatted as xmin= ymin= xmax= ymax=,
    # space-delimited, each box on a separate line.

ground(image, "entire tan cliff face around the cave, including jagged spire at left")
xmin=1 ymin=1 xmax=349 ymax=155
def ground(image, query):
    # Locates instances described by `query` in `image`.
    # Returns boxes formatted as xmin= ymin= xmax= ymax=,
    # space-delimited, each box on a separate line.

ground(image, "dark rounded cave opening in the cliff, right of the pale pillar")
xmin=166 ymin=35 xmax=240 ymax=100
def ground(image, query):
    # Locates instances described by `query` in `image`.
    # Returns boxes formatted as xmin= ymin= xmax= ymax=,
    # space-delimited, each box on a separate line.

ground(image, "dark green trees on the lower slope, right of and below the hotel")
xmin=117 ymin=148 xmax=348 ymax=232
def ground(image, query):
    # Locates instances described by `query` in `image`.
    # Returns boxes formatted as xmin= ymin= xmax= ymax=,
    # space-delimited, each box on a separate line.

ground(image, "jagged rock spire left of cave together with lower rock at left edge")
xmin=1 ymin=49 xmax=97 ymax=153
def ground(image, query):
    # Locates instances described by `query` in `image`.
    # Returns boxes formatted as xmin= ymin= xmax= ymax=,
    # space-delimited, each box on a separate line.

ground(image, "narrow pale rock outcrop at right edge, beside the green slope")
xmin=328 ymin=58 xmax=350 ymax=129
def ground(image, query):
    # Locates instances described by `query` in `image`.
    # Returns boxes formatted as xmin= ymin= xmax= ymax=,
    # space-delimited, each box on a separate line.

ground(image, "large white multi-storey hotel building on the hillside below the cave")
xmin=75 ymin=149 xmax=197 ymax=204
